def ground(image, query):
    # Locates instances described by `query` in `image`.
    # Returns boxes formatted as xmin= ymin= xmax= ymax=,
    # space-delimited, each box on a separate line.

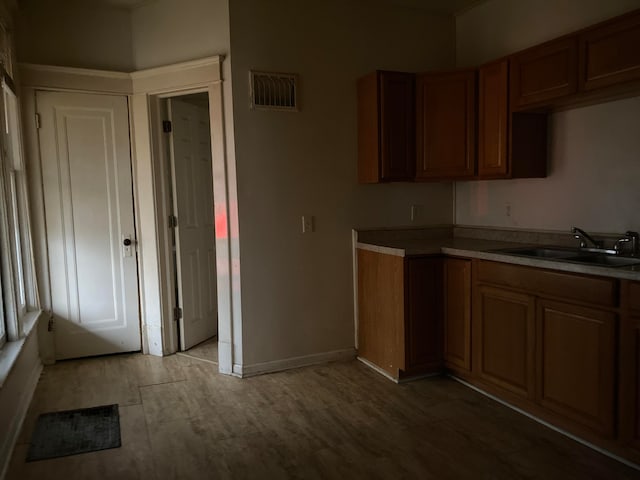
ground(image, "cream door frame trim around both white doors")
xmin=19 ymin=56 xmax=243 ymax=374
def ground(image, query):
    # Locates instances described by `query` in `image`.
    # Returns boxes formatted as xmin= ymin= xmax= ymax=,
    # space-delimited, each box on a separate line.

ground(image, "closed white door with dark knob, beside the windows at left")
xmin=36 ymin=92 xmax=141 ymax=359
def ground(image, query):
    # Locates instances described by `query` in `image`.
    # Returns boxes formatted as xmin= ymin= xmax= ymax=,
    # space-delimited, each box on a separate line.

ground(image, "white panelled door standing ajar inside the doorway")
xmin=169 ymin=98 xmax=218 ymax=350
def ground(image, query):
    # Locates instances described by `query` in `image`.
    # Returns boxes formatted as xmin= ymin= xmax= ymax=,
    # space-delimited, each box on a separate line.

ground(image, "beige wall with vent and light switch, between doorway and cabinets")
xmin=230 ymin=0 xmax=454 ymax=366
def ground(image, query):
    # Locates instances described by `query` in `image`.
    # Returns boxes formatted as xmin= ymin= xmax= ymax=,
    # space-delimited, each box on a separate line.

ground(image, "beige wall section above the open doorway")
xmin=131 ymin=0 xmax=229 ymax=70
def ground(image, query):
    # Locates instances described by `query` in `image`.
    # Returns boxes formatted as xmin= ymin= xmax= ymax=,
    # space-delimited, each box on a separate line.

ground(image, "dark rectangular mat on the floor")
xmin=27 ymin=405 xmax=120 ymax=462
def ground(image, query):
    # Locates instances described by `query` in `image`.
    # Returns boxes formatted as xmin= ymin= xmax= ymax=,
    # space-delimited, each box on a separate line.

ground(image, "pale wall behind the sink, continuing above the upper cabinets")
xmin=456 ymin=0 xmax=640 ymax=233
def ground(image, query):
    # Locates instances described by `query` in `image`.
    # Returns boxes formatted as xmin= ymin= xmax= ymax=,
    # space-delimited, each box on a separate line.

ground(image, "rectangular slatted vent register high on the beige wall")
xmin=249 ymin=71 xmax=298 ymax=112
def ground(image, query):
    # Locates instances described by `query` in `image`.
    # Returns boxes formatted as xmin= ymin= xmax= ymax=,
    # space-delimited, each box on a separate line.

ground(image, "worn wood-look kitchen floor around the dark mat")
xmin=7 ymin=354 xmax=640 ymax=480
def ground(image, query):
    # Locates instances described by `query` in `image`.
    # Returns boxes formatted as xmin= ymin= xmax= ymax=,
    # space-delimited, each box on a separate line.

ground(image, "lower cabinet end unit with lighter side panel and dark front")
xmin=358 ymin=249 xmax=443 ymax=379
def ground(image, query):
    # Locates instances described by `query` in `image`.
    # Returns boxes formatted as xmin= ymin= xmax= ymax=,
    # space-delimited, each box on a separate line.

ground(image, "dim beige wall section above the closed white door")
xmin=16 ymin=0 xmax=134 ymax=72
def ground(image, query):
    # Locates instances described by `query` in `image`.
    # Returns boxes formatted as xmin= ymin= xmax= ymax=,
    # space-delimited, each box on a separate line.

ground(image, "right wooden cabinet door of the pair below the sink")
xmin=537 ymin=300 xmax=616 ymax=436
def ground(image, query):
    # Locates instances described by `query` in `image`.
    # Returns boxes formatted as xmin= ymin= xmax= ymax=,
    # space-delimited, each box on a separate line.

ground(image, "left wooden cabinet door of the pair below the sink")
xmin=472 ymin=285 xmax=535 ymax=399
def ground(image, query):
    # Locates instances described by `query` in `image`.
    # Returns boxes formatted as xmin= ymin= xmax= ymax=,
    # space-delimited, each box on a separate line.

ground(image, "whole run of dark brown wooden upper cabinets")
xmin=358 ymin=10 xmax=640 ymax=183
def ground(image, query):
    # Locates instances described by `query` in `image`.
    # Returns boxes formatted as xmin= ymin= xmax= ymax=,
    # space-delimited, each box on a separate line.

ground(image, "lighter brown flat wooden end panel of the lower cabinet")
xmin=358 ymin=249 xmax=405 ymax=377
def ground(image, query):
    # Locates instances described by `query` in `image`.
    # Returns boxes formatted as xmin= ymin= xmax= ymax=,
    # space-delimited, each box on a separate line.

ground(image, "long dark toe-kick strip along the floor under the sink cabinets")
xmin=445 ymin=369 xmax=640 ymax=468
